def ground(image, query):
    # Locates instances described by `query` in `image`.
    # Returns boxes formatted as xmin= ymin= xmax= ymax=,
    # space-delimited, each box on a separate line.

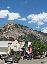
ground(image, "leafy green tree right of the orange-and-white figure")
xmin=32 ymin=40 xmax=47 ymax=55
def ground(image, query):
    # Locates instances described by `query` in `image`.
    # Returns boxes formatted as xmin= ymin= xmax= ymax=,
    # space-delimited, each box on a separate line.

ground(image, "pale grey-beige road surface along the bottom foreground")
xmin=0 ymin=58 xmax=47 ymax=64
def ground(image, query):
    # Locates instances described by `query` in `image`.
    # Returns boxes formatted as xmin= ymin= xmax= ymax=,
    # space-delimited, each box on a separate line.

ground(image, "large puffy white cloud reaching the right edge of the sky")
xmin=27 ymin=12 xmax=47 ymax=25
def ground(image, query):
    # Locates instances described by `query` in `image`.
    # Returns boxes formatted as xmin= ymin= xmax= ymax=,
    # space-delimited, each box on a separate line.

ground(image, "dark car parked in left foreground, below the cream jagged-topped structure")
xmin=4 ymin=51 xmax=21 ymax=63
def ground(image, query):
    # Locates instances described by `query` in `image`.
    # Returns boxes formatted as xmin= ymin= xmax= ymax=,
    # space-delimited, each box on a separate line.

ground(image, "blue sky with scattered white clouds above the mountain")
xmin=0 ymin=0 xmax=47 ymax=33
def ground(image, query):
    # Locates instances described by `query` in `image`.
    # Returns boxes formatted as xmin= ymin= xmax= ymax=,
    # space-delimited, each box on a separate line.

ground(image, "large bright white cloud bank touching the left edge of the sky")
xmin=0 ymin=10 xmax=21 ymax=20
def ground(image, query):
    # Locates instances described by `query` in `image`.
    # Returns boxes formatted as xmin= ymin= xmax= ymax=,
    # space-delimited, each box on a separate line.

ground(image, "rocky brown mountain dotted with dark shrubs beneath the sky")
xmin=0 ymin=24 xmax=47 ymax=43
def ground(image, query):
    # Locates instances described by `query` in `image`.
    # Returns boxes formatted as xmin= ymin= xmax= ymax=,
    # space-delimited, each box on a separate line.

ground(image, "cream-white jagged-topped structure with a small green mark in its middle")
xmin=10 ymin=40 xmax=25 ymax=51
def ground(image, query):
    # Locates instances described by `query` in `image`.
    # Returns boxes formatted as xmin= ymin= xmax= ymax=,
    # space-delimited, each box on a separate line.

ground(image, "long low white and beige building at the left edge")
xmin=0 ymin=41 xmax=10 ymax=55
